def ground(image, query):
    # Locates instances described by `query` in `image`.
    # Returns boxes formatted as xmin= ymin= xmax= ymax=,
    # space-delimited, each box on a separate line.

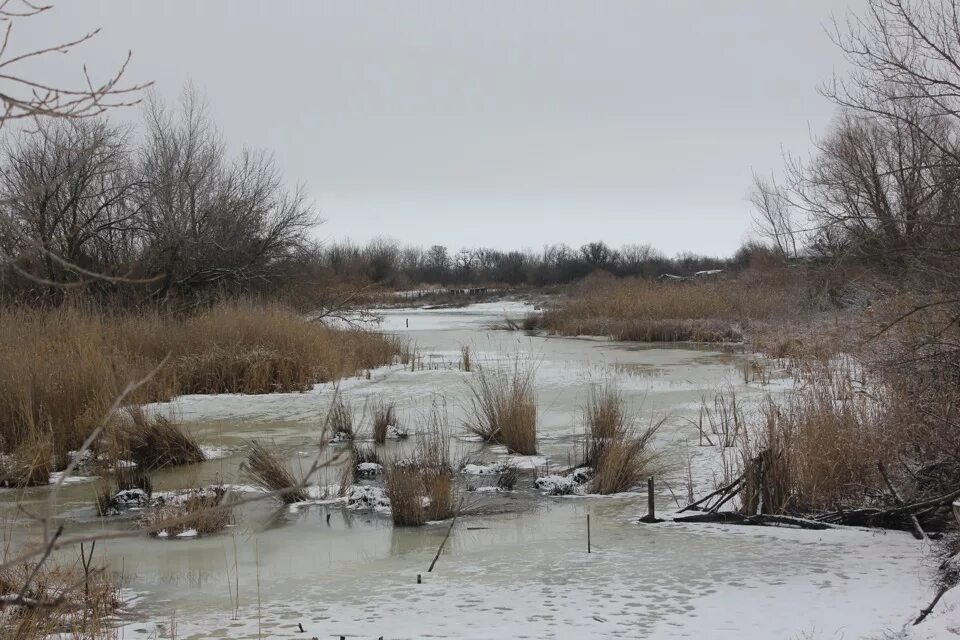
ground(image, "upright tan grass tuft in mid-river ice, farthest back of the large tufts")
xmin=466 ymin=362 xmax=537 ymax=455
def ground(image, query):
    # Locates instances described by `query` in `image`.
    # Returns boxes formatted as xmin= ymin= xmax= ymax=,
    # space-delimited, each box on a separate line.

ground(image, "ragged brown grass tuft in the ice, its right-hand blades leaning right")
xmin=583 ymin=385 xmax=663 ymax=495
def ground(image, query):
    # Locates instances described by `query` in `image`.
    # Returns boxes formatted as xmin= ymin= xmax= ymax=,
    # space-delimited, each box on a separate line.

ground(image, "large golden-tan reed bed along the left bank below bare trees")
xmin=0 ymin=302 xmax=402 ymax=481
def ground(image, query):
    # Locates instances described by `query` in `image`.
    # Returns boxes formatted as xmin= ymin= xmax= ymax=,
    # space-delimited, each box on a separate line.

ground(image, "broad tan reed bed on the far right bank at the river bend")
xmin=538 ymin=272 xmax=813 ymax=342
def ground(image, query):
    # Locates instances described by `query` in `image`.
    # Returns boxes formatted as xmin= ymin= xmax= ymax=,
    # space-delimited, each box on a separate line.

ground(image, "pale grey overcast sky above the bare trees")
xmin=14 ymin=0 xmax=860 ymax=254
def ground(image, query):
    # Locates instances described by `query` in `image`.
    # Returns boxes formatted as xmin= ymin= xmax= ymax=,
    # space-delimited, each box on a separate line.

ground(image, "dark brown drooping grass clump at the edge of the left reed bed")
xmin=114 ymin=407 xmax=205 ymax=471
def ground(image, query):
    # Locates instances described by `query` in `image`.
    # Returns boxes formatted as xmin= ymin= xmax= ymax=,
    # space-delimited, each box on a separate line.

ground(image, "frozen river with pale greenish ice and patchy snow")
xmin=3 ymin=302 xmax=930 ymax=640
